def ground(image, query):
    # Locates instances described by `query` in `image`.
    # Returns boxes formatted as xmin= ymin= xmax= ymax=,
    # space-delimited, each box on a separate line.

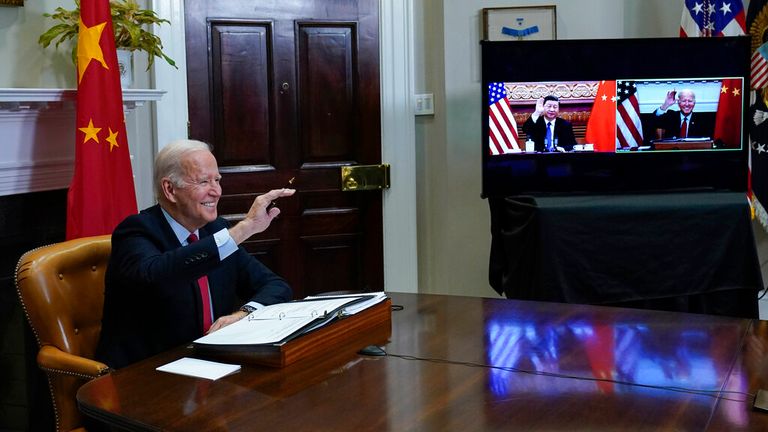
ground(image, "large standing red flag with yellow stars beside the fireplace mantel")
xmin=67 ymin=0 xmax=136 ymax=239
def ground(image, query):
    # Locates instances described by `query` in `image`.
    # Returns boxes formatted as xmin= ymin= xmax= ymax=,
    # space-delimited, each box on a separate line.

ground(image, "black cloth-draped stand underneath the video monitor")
xmin=488 ymin=192 xmax=763 ymax=318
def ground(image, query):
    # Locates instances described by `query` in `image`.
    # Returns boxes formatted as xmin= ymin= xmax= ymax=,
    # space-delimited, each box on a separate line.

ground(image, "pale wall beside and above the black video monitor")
xmin=414 ymin=0 xmax=682 ymax=296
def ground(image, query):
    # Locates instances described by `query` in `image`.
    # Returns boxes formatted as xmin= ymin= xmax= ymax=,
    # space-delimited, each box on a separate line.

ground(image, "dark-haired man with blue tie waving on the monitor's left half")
xmin=523 ymin=95 xmax=576 ymax=152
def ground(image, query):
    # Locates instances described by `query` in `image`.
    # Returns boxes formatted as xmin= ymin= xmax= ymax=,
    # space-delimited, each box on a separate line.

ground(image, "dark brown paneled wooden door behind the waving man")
xmin=185 ymin=0 xmax=383 ymax=298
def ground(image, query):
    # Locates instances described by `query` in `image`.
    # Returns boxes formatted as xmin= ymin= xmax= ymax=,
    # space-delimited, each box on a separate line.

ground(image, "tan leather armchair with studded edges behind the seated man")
xmin=16 ymin=235 xmax=112 ymax=431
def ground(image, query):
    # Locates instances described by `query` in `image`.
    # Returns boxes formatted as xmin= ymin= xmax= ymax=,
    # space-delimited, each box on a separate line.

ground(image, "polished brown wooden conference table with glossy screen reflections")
xmin=77 ymin=293 xmax=768 ymax=432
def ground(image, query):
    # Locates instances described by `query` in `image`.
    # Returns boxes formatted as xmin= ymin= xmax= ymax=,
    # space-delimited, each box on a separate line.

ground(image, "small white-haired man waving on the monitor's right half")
xmin=654 ymin=89 xmax=714 ymax=138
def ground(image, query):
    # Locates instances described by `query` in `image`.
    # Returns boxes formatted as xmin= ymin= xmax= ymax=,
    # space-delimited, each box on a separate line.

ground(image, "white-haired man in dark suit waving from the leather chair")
xmin=96 ymin=140 xmax=295 ymax=368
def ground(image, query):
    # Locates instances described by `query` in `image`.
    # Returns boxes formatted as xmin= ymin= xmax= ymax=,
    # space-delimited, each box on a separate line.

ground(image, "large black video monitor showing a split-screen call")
xmin=482 ymin=37 xmax=749 ymax=196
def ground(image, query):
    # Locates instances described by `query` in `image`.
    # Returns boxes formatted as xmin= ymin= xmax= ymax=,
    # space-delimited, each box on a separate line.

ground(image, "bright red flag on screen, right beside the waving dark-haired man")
xmin=585 ymin=81 xmax=616 ymax=152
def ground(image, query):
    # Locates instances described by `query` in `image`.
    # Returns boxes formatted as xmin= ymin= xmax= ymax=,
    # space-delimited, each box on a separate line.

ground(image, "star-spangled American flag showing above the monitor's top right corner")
xmin=680 ymin=0 xmax=747 ymax=37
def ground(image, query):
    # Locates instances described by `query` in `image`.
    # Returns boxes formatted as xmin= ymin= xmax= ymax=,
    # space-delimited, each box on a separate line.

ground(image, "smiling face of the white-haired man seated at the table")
xmin=164 ymin=150 xmax=221 ymax=232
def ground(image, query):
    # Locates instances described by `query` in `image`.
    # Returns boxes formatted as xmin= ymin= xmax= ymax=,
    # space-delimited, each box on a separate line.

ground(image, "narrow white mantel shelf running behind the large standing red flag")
xmin=0 ymin=88 xmax=166 ymax=111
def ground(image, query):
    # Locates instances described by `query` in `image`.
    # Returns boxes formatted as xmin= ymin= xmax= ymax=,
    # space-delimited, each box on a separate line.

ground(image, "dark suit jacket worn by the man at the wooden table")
xmin=96 ymin=205 xmax=292 ymax=368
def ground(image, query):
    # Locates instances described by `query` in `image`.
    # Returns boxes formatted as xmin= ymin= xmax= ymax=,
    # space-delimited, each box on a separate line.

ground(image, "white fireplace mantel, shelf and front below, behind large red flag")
xmin=0 ymin=88 xmax=165 ymax=195
